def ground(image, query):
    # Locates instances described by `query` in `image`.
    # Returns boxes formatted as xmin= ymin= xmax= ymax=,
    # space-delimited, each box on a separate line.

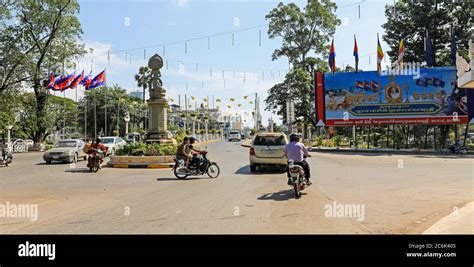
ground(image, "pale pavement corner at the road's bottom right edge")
xmin=423 ymin=201 xmax=474 ymax=234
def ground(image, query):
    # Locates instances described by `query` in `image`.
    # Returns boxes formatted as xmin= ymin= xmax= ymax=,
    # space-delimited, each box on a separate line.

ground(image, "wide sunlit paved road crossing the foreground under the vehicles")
xmin=0 ymin=142 xmax=474 ymax=233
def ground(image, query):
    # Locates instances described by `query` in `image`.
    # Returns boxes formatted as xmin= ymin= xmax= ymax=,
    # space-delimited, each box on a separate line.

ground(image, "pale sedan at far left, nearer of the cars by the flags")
xmin=43 ymin=139 xmax=87 ymax=164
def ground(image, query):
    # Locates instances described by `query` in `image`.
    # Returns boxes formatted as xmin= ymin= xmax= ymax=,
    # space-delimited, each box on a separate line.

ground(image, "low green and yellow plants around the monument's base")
xmin=116 ymin=142 xmax=177 ymax=156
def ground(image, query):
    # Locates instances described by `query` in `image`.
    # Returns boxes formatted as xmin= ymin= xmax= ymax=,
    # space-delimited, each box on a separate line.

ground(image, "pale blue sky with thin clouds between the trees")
xmin=61 ymin=0 xmax=393 ymax=125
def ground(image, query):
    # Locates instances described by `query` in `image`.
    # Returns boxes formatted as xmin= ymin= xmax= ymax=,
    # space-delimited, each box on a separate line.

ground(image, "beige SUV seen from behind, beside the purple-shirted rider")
xmin=249 ymin=133 xmax=288 ymax=172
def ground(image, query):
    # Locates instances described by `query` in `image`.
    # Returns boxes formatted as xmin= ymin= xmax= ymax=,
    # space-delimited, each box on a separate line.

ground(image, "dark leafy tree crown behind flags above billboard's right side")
xmin=382 ymin=0 xmax=474 ymax=66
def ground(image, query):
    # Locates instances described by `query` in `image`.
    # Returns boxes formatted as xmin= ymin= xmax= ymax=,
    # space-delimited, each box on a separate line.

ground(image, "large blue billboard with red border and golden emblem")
xmin=315 ymin=67 xmax=468 ymax=126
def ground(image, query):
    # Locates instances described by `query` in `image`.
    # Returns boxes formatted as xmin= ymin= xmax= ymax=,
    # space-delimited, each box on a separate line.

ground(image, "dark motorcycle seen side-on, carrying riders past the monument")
xmin=173 ymin=151 xmax=220 ymax=179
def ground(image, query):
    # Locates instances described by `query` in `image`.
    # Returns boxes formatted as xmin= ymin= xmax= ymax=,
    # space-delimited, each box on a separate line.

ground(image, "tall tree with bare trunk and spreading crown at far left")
xmin=0 ymin=0 xmax=85 ymax=147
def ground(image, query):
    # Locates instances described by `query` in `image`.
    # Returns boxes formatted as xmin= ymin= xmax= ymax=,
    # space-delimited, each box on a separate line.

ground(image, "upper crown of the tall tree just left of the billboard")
xmin=265 ymin=0 xmax=340 ymax=67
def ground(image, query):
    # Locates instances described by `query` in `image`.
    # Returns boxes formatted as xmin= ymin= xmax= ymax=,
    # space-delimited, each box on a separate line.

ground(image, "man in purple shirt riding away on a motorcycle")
xmin=285 ymin=133 xmax=311 ymax=185
